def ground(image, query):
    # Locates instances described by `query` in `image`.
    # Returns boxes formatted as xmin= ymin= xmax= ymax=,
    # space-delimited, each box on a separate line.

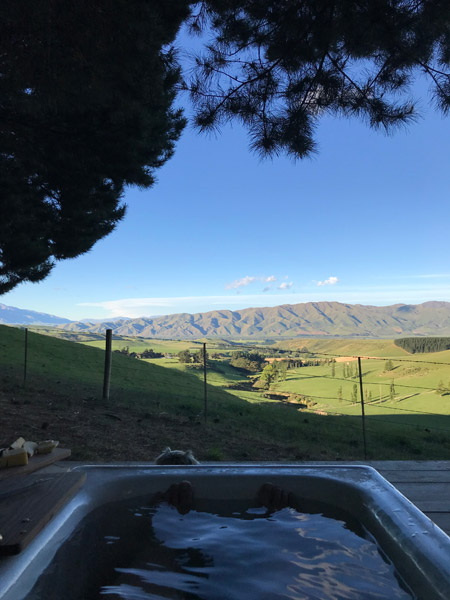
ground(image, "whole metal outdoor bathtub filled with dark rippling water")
xmin=0 ymin=465 xmax=450 ymax=600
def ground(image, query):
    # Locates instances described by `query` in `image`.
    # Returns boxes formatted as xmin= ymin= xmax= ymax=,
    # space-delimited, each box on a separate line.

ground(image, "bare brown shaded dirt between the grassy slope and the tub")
xmin=0 ymin=382 xmax=311 ymax=462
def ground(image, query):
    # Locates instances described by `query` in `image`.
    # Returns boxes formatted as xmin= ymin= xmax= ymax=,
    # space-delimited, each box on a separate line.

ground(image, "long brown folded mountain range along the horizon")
xmin=53 ymin=302 xmax=450 ymax=339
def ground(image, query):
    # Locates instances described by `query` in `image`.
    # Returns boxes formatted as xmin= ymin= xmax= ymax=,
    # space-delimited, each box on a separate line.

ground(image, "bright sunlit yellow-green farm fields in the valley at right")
xmin=136 ymin=340 xmax=450 ymax=434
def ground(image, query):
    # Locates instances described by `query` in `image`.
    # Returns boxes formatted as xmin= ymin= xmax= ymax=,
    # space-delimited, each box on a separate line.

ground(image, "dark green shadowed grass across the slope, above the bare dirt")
xmin=0 ymin=327 xmax=450 ymax=460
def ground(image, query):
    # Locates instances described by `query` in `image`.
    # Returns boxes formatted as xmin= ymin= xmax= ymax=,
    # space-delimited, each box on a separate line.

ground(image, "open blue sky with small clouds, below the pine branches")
xmin=0 ymin=77 xmax=450 ymax=319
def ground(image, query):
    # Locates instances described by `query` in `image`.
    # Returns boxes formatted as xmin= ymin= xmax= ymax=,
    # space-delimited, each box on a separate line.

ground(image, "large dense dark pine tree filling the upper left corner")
xmin=0 ymin=0 xmax=189 ymax=294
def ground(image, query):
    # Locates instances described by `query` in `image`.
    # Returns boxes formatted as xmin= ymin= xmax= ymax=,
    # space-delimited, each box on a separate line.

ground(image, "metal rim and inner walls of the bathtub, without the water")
xmin=0 ymin=464 xmax=450 ymax=600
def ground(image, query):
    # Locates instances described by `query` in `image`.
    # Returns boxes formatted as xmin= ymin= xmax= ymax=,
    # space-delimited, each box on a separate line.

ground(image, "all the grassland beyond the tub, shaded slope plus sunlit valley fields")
xmin=0 ymin=326 xmax=450 ymax=461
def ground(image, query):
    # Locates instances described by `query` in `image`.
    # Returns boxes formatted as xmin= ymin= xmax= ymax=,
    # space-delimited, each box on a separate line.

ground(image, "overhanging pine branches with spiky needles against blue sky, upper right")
xmin=187 ymin=0 xmax=450 ymax=158
